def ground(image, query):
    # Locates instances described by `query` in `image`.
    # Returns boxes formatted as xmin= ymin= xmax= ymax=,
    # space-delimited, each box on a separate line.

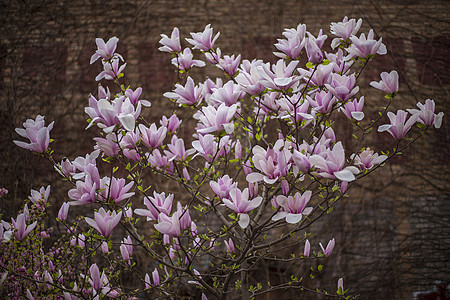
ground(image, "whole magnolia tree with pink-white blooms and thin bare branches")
xmin=0 ymin=17 xmax=443 ymax=299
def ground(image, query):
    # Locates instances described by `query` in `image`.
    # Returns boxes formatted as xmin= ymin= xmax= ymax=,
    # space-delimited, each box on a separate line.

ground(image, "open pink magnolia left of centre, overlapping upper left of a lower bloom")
xmin=134 ymin=191 xmax=173 ymax=221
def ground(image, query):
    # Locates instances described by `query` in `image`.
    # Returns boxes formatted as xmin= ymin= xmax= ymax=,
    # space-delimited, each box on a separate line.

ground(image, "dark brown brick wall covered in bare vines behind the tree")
xmin=0 ymin=0 xmax=450 ymax=299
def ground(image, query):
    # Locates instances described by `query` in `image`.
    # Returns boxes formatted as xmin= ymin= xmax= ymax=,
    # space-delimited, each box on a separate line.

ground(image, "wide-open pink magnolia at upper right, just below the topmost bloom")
xmin=347 ymin=29 xmax=387 ymax=58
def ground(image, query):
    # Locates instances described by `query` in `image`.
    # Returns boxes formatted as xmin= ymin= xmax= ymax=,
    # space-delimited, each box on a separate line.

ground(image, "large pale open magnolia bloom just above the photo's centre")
xmin=197 ymin=103 xmax=237 ymax=134
